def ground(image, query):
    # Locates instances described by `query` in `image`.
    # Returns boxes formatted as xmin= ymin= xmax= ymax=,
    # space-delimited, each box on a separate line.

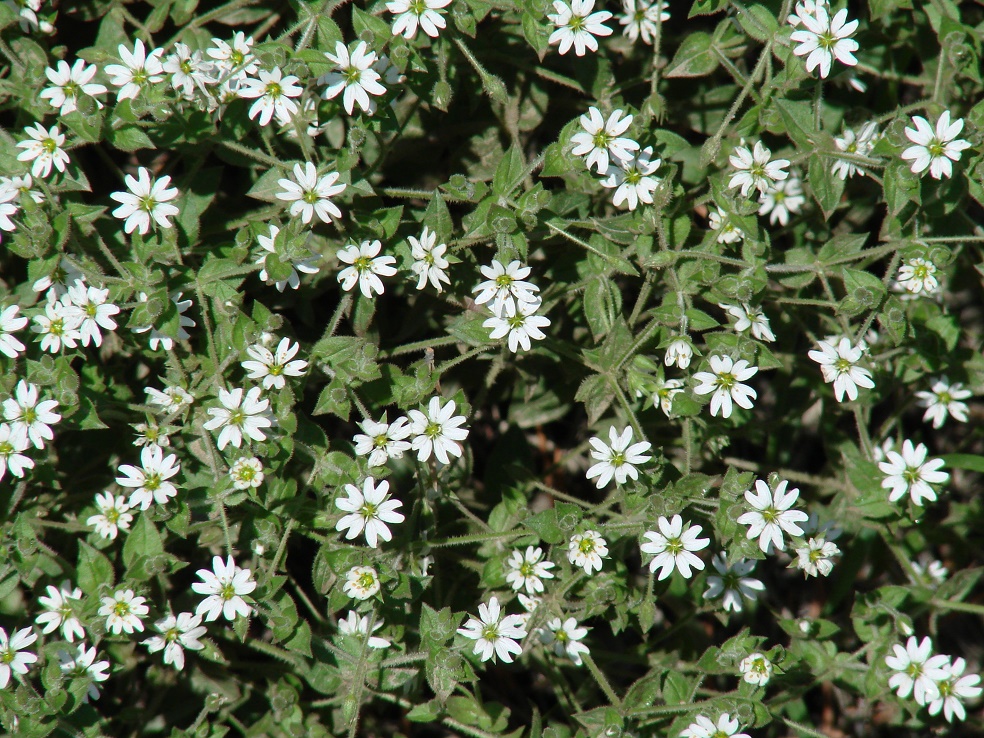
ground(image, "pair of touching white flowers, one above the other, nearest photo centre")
xmin=472 ymin=261 xmax=550 ymax=353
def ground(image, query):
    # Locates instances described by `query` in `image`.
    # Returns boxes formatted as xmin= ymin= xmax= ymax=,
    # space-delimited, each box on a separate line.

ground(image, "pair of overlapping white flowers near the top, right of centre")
xmin=571 ymin=107 xmax=662 ymax=210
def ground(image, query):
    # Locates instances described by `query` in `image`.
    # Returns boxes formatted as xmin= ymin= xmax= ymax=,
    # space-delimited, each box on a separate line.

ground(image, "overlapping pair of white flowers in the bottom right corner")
xmin=885 ymin=636 xmax=984 ymax=723
